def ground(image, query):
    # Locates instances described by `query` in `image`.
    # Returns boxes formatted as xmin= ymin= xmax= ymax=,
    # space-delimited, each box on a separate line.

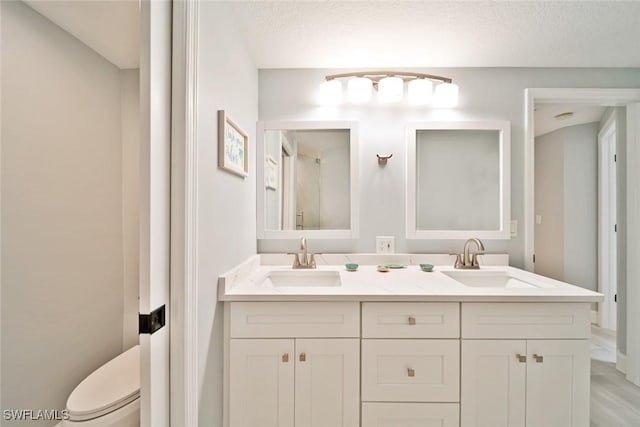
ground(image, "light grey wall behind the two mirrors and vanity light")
xmin=258 ymin=68 xmax=640 ymax=267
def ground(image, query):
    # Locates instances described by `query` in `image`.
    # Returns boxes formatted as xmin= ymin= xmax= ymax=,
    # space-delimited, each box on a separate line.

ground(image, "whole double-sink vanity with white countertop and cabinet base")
xmin=219 ymin=254 xmax=601 ymax=427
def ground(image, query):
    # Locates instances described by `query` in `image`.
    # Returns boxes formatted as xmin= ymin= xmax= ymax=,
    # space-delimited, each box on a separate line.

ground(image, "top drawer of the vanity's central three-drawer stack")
xmin=362 ymin=302 xmax=460 ymax=338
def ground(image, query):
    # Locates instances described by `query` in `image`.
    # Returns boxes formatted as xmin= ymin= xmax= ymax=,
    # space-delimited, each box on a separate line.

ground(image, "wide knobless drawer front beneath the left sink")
xmin=230 ymin=301 xmax=360 ymax=338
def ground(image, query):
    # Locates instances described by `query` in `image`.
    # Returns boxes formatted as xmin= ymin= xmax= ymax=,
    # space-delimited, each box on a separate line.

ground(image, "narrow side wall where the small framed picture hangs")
xmin=197 ymin=2 xmax=258 ymax=427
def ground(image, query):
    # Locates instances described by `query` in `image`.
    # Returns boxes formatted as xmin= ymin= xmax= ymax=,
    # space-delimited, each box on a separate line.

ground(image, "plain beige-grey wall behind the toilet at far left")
xmin=0 ymin=2 xmax=123 ymax=426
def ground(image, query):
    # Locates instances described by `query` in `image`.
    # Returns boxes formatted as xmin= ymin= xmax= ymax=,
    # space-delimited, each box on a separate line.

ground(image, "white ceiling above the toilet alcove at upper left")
xmin=25 ymin=0 xmax=140 ymax=69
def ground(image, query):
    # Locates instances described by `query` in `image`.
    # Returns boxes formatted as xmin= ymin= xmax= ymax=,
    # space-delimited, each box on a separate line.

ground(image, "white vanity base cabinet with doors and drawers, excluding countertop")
xmin=224 ymin=300 xmax=590 ymax=427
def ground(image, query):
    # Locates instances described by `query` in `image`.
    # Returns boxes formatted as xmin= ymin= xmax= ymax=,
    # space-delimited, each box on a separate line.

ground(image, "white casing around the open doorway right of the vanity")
xmin=524 ymin=88 xmax=640 ymax=385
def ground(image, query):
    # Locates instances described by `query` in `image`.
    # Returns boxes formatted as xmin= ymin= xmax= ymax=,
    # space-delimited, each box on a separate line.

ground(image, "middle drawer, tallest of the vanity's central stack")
xmin=361 ymin=340 xmax=460 ymax=402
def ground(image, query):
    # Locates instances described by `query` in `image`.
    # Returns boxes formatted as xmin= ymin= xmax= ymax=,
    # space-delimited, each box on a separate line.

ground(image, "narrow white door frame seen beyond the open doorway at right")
xmin=598 ymin=114 xmax=618 ymax=330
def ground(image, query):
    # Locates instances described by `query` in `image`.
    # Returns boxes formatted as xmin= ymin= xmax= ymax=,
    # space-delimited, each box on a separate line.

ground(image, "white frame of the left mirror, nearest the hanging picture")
xmin=256 ymin=121 xmax=360 ymax=239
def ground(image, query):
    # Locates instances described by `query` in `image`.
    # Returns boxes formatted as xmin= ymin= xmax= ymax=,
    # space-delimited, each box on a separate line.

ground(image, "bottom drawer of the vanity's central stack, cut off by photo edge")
xmin=362 ymin=402 xmax=460 ymax=427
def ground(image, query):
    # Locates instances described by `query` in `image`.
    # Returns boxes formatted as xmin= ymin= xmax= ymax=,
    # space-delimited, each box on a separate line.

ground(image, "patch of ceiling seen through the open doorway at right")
xmin=534 ymin=104 xmax=607 ymax=136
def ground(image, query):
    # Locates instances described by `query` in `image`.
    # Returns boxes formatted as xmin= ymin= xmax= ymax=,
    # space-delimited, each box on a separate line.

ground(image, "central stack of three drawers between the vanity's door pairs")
xmin=361 ymin=302 xmax=460 ymax=427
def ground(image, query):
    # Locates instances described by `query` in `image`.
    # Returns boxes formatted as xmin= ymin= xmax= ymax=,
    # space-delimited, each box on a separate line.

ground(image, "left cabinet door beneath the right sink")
xmin=460 ymin=340 xmax=530 ymax=427
